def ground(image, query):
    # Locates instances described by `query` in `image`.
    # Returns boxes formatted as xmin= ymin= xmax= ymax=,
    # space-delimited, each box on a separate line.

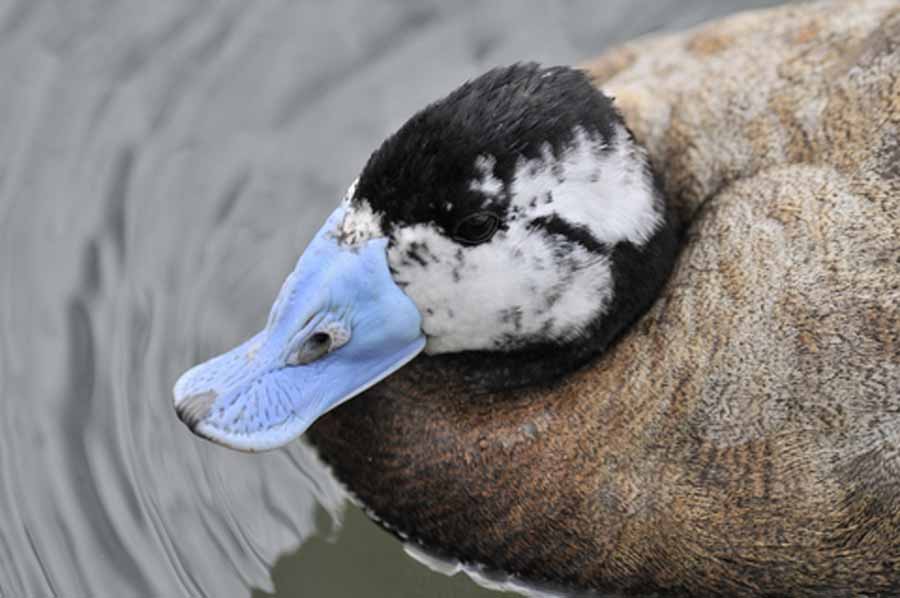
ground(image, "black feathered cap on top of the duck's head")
xmin=354 ymin=63 xmax=623 ymax=234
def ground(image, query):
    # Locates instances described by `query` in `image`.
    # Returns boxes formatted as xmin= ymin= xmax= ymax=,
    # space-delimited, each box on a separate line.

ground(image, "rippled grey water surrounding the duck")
xmin=0 ymin=0 xmax=788 ymax=598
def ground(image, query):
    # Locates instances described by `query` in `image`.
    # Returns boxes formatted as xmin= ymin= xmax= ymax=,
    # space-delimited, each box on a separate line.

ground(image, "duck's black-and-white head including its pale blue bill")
xmin=174 ymin=64 xmax=674 ymax=450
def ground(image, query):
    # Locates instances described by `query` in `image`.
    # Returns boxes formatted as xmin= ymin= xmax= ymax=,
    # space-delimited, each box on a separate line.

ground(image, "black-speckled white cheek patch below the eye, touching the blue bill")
xmin=388 ymin=222 xmax=612 ymax=354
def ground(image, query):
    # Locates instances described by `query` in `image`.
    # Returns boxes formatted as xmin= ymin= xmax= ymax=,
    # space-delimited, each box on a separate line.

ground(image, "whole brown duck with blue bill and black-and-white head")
xmin=174 ymin=0 xmax=900 ymax=596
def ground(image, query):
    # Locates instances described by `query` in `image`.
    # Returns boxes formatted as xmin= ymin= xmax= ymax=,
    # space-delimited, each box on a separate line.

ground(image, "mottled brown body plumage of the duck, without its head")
xmin=309 ymin=0 xmax=900 ymax=595
